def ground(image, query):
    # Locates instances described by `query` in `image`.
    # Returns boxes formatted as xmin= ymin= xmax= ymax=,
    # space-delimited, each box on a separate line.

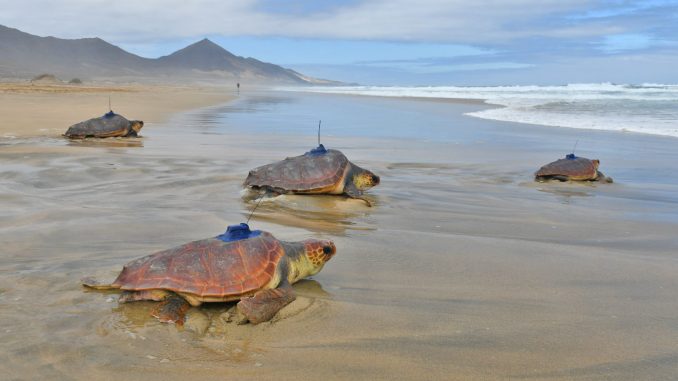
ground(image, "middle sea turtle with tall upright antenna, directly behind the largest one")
xmin=244 ymin=144 xmax=379 ymax=206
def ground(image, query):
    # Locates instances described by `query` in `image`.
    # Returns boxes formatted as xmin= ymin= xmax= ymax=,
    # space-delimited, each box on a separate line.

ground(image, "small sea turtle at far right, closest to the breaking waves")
xmin=534 ymin=153 xmax=612 ymax=183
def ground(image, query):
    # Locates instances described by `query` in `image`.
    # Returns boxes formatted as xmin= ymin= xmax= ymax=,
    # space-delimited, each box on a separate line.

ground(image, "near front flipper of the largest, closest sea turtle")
xmin=238 ymin=281 xmax=297 ymax=324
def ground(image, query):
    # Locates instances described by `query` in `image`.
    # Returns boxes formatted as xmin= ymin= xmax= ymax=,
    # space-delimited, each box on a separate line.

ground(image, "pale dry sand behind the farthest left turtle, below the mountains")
xmin=0 ymin=82 xmax=235 ymax=137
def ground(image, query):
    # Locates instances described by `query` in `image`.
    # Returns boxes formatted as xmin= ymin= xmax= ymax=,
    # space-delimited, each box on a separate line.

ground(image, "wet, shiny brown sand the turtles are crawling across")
xmin=0 ymin=93 xmax=678 ymax=380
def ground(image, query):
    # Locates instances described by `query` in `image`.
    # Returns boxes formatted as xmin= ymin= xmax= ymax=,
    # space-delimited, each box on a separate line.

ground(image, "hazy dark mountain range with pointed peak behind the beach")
xmin=0 ymin=25 xmax=334 ymax=84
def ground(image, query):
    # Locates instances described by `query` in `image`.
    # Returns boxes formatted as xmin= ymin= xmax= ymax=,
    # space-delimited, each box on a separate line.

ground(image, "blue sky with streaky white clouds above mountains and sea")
xmin=0 ymin=0 xmax=678 ymax=85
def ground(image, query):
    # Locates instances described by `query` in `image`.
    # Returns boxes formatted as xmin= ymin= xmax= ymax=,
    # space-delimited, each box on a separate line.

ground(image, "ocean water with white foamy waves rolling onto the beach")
xmin=287 ymin=83 xmax=678 ymax=137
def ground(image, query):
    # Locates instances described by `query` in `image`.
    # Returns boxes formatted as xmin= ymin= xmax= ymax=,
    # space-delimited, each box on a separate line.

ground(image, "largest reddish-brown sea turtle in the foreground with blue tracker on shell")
xmin=82 ymin=224 xmax=336 ymax=324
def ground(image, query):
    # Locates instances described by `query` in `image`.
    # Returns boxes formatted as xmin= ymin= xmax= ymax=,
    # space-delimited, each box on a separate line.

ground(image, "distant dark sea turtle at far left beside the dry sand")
xmin=64 ymin=111 xmax=144 ymax=139
